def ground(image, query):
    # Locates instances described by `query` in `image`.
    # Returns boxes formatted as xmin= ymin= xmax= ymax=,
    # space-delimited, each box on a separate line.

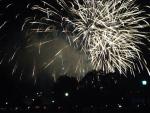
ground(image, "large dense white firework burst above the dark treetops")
xmin=23 ymin=0 xmax=150 ymax=75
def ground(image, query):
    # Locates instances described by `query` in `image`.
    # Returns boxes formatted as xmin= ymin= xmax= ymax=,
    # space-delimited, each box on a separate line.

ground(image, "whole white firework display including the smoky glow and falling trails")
xmin=0 ymin=0 xmax=150 ymax=79
